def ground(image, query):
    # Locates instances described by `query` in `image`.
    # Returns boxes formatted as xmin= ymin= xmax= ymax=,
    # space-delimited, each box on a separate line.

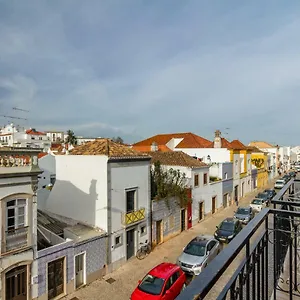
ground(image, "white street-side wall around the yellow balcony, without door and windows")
xmin=109 ymin=161 xmax=151 ymax=262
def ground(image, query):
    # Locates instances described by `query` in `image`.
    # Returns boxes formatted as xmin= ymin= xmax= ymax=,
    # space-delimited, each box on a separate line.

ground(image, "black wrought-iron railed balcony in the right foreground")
xmin=176 ymin=179 xmax=300 ymax=300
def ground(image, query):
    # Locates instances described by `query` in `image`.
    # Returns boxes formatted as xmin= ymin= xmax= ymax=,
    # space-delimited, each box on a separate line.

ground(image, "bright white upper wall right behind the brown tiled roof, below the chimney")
xmin=174 ymin=148 xmax=230 ymax=163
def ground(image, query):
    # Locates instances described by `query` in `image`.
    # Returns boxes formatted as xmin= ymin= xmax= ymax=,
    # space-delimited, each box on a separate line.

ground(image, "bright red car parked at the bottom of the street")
xmin=130 ymin=263 xmax=186 ymax=300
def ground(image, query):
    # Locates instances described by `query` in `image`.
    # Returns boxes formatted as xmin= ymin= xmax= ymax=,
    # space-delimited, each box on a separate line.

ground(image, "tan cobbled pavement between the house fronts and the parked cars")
xmin=64 ymin=179 xmax=276 ymax=300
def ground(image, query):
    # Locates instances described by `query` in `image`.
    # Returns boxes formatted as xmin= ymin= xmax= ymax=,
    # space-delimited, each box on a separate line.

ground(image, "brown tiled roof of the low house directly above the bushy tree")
xmin=147 ymin=151 xmax=207 ymax=168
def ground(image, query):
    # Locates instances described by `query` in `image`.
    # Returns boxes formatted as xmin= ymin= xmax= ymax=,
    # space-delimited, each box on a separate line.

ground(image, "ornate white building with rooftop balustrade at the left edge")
xmin=0 ymin=147 xmax=41 ymax=300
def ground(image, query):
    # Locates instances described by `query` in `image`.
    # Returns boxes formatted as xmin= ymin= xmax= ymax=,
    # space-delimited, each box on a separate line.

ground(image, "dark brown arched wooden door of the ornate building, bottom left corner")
xmin=5 ymin=266 xmax=27 ymax=300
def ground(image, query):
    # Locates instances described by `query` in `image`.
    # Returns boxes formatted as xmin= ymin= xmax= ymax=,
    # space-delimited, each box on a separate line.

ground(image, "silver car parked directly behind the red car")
xmin=177 ymin=235 xmax=223 ymax=275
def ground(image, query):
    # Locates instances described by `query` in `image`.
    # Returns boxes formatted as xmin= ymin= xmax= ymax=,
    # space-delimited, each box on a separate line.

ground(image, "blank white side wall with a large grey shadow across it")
xmin=45 ymin=155 xmax=108 ymax=231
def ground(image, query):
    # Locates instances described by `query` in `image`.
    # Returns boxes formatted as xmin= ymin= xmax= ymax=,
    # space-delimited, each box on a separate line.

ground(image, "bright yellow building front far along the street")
xmin=251 ymin=147 xmax=269 ymax=188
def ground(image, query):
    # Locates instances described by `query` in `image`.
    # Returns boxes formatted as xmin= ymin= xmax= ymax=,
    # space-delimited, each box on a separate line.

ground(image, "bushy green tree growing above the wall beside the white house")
xmin=151 ymin=161 xmax=191 ymax=207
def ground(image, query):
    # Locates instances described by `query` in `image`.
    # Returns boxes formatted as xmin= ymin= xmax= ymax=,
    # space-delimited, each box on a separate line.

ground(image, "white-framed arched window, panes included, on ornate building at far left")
xmin=6 ymin=199 xmax=27 ymax=231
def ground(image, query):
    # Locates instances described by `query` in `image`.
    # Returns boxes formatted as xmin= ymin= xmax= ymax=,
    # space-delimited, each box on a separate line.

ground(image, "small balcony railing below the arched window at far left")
xmin=2 ymin=227 xmax=29 ymax=253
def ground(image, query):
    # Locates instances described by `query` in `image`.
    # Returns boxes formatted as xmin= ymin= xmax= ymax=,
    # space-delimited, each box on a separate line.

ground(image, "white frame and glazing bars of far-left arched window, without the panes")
xmin=6 ymin=198 xmax=28 ymax=231
